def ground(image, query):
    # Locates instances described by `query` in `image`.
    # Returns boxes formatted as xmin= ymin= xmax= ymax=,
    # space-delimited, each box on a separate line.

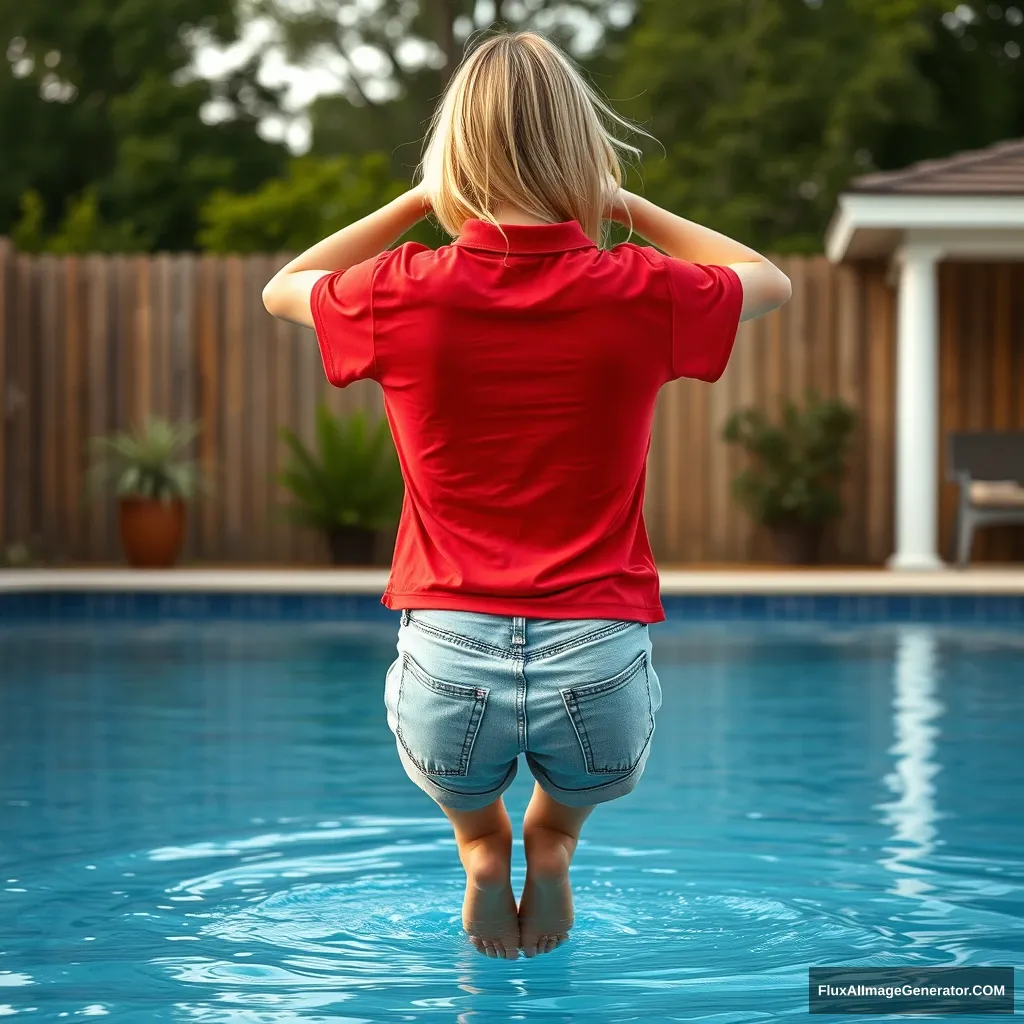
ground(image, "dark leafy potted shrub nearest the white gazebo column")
xmin=722 ymin=391 xmax=856 ymax=564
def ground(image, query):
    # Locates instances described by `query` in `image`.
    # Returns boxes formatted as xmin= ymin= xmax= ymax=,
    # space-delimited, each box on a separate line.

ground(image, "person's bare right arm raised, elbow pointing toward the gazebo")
xmin=614 ymin=189 xmax=793 ymax=321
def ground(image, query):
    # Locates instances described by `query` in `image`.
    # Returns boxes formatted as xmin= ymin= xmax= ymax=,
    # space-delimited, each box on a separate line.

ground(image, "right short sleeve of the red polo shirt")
xmin=665 ymin=257 xmax=743 ymax=383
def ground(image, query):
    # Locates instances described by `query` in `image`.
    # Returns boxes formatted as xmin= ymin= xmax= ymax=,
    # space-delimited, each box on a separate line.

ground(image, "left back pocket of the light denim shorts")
xmin=395 ymin=653 xmax=487 ymax=775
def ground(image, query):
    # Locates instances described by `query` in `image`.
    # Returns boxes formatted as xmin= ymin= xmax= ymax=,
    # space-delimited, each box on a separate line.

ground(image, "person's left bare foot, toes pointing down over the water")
xmin=462 ymin=844 xmax=519 ymax=959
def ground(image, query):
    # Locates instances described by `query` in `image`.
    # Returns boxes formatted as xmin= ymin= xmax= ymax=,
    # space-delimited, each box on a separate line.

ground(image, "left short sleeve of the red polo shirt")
xmin=309 ymin=256 xmax=380 ymax=387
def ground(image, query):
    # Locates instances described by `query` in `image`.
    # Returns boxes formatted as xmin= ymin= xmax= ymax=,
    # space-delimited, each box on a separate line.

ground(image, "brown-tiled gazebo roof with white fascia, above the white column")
xmin=825 ymin=139 xmax=1024 ymax=262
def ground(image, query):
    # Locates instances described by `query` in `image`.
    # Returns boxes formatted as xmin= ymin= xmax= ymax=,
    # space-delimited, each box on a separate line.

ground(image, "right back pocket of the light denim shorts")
xmin=561 ymin=652 xmax=654 ymax=775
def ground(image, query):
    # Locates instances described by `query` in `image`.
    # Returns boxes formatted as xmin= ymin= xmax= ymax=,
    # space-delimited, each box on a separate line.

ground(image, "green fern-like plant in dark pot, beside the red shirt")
xmin=281 ymin=404 xmax=404 ymax=565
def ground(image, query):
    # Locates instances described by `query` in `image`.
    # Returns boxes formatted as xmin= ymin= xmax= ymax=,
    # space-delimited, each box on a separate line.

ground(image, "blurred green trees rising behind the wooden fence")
xmin=0 ymin=0 xmax=1024 ymax=252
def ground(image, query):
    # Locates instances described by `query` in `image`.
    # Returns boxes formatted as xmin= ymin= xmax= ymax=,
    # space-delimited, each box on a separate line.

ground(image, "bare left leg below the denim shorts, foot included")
xmin=438 ymin=798 xmax=519 ymax=959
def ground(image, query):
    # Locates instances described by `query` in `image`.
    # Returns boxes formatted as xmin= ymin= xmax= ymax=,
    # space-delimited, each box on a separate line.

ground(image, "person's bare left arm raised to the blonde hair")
xmin=263 ymin=187 xmax=427 ymax=327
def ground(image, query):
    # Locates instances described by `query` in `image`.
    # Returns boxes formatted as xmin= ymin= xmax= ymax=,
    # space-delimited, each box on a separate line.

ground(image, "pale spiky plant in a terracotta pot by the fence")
xmin=89 ymin=417 xmax=199 ymax=568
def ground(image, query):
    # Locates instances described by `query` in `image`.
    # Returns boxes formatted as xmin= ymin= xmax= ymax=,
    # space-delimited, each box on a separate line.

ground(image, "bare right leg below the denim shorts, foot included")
xmin=519 ymin=784 xmax=594 ymax=956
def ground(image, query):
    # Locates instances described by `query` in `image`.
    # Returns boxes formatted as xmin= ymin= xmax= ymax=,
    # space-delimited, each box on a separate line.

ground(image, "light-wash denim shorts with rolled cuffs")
xmin=384 ymin=610 xmax=662 ymax=810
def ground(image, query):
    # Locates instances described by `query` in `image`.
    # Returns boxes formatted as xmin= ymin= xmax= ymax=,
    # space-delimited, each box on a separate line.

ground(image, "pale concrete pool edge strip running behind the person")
xmin=0 ymin=565 xmax=1024 ymax=595
